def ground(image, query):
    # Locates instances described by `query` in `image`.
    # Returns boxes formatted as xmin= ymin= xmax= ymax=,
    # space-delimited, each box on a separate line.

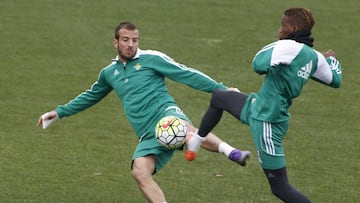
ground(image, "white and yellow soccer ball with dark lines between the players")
xmin=155 ymin=116 xmax=187 ymax=149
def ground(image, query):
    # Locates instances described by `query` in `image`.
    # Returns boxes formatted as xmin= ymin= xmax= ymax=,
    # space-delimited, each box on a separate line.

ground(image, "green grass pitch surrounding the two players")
xmin=0 ymin=0 xmax=360 ymax=203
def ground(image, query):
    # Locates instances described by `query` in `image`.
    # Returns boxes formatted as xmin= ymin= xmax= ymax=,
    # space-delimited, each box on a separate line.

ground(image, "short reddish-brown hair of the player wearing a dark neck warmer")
xmin=284 ymin=8 xmax=315 ymax=31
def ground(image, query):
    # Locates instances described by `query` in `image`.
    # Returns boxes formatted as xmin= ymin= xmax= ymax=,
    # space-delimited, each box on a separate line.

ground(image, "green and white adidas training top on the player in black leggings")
xmin=251 ymin=40 xmax=342 ymax=122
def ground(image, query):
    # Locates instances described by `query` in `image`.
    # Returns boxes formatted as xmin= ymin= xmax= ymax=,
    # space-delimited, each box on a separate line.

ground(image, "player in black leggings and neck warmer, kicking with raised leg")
xmin=186 ymin=8 xmax=342 ymax=203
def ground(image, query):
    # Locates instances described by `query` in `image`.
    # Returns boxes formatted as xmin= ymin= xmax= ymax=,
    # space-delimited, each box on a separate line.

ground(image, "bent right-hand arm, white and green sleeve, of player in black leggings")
xmin=311 ymin=52 xmax=342 ymax=88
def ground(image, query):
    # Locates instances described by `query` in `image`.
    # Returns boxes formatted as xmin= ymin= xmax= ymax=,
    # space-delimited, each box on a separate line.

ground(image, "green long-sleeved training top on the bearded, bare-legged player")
xmin=56 ymin=49 xmax=226 ymax=138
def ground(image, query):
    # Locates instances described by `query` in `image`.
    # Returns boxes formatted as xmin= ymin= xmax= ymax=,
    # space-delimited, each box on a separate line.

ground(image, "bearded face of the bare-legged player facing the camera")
xmin=114 ymin=29 xmax=139 ymax=62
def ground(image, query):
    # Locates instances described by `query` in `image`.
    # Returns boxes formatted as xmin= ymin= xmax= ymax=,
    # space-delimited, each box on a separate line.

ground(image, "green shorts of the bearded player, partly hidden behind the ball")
xmin=131 ymin=106 xmax=190 ymax=173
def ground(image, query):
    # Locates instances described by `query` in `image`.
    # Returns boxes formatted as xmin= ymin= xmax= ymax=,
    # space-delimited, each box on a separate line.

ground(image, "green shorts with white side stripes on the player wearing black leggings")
xmin=249 ymin=117 xmax=288 ymax=169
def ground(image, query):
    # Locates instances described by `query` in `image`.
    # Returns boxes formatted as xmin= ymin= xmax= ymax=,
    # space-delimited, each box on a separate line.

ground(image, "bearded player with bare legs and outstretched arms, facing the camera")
xmin=37 ymin=22 xmax=250 ymax=203
